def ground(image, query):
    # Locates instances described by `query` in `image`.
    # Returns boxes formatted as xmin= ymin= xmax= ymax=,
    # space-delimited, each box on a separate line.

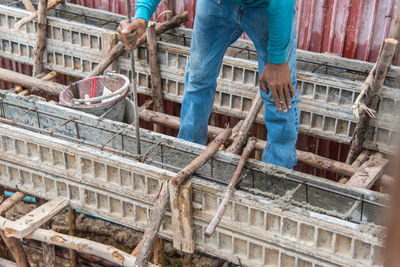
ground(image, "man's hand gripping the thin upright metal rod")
xmin=118 ymin=19 xmax=147 ymax=50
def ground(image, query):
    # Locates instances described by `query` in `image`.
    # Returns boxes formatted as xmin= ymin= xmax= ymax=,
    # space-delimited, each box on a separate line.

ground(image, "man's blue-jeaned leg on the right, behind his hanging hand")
xmin=240 ymin=7 xmax=299 ymax=168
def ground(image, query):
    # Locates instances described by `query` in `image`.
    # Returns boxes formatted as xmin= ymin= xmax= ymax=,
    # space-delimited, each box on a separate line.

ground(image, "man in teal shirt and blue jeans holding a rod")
xmin=118 ymin=0 xmax=299 ymax=168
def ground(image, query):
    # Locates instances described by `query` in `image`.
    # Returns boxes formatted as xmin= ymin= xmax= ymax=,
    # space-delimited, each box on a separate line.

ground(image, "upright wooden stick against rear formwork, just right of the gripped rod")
xmin=147 ymin=22 xmax=165 ymax=133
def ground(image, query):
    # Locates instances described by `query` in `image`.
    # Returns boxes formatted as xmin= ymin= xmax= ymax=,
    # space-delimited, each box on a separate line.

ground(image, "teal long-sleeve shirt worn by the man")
xmin=135 ymin=0 xmax=296 ymax=64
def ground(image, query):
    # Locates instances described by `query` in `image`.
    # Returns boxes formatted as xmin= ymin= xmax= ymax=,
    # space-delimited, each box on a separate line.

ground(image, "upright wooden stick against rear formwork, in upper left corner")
xmin=33 ymin=0 xmax=47 ymax=76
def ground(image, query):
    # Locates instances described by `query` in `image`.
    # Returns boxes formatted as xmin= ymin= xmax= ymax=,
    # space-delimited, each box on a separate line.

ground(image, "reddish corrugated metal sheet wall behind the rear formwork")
xmin=69 ymin=0 xmax=400 ymax=64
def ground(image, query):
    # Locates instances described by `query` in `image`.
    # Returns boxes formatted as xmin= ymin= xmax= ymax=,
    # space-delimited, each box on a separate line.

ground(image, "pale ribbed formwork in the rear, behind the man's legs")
xmin=0 ymin=2 xmax=400 ymax=153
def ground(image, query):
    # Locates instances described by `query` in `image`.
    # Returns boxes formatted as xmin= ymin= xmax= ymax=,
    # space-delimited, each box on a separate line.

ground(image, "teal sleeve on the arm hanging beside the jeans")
xmin=267 ymin=0 xmax=296 ymax=64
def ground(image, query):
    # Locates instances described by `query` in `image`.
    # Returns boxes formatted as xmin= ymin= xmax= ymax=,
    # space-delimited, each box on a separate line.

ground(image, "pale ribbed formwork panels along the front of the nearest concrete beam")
xmin=0 ymin=121 xmax=382 ymax=267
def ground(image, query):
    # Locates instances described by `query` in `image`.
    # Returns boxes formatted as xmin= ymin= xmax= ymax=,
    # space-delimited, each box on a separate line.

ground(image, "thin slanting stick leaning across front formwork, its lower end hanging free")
xmin=204 ymin=137 xmax=257 ymax=237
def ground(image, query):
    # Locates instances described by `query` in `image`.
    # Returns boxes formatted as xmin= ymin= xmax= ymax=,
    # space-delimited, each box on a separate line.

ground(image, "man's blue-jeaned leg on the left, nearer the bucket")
xmin=178 ymin=0 xmax=243 ymax=145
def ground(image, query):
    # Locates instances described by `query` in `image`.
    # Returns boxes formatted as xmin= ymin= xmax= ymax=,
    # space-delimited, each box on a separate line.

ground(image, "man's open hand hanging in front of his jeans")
xmin=260 ymin=62 xmax=296 ymax=112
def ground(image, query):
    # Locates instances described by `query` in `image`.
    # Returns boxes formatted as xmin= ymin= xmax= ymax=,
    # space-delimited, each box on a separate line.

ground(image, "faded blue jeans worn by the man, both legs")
xmin=178 ymin=0 xmax=299 ymax=168
